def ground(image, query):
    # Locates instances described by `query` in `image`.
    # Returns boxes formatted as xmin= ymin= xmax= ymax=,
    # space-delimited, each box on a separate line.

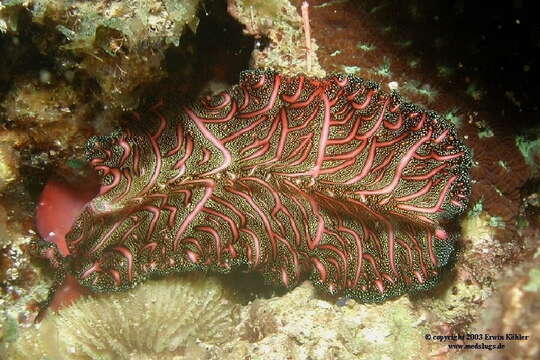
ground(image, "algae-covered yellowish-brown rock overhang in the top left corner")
xmin=0 ymin=0 xmax=200 ymax=110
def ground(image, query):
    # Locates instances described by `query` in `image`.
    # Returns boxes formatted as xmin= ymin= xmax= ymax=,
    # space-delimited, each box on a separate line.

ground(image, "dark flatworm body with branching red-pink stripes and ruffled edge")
xmin=53 ymin=71 xmax=470 ymax=301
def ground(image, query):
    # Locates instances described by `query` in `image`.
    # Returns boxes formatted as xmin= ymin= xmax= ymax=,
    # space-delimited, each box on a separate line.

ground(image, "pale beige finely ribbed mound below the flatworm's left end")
xmin=6 ymin=276 xmax=240 ymax=360
